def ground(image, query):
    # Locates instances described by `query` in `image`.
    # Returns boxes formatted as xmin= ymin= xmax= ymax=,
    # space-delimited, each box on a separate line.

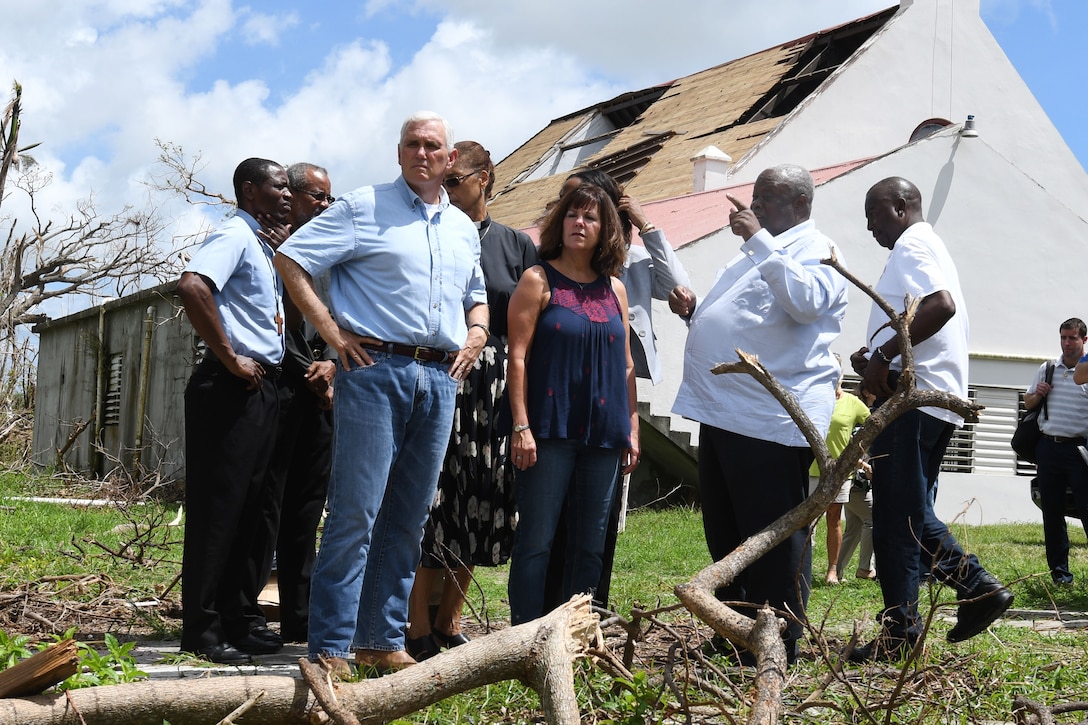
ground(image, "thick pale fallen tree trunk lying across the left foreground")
xmin=0 ymin=597 xmax=598 ymax=725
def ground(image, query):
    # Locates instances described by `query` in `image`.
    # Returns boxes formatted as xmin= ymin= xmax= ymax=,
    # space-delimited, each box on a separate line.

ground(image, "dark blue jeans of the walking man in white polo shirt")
xmin=870 ymin=410 xmax=986 ymax=640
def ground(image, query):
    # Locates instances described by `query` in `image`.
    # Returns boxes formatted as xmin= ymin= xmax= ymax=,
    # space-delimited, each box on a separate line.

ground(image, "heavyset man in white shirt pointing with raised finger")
xmin=669 ymin=164 xmax=846 ymax=662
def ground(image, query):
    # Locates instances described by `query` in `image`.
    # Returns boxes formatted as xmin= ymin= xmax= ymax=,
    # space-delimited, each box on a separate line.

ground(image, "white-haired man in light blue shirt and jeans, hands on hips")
xmin=275 ymin=112 xmax=489 ymax=672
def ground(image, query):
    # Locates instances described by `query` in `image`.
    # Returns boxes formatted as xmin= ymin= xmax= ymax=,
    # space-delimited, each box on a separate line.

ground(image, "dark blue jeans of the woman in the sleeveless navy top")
xmin=508 ymin=440 xmax=623 ymax=625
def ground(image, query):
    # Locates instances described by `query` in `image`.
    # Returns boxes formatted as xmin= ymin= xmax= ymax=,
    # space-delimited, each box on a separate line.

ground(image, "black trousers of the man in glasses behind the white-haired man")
xmin=257 ymin=379 xmax=333 ymax=642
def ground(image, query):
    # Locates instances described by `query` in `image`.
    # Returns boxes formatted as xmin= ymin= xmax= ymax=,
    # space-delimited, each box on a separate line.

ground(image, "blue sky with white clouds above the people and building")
xmin=0 ymin=0 xmax=1088 ymax=253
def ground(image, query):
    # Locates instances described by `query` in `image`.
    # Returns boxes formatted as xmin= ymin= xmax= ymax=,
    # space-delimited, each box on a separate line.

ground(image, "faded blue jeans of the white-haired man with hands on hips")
xmin=309 ymin=353 xmax=457 ymax=658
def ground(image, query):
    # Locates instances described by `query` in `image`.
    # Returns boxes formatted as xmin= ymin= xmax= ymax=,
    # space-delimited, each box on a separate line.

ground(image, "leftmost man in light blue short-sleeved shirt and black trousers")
xmin=177 ymin=158 xmax=290 ymax=664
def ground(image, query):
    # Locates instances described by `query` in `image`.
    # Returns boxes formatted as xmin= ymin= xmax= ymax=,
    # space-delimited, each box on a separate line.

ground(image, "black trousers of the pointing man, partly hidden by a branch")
xmin=698 ymin=425 xmax=814 ymax=643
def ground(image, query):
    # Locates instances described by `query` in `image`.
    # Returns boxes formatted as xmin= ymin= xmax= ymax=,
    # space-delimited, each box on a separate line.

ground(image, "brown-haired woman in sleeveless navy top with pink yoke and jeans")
xmin=507 ymin=184 xmax=639 ymax=624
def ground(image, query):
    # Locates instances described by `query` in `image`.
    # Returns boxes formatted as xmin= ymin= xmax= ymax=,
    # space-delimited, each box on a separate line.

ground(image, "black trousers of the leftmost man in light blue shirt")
xmin=182 ymin=359 xmax=280 ymax=652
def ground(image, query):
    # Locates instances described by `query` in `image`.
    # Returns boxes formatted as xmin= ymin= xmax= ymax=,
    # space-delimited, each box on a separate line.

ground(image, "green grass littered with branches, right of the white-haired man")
xmin=448 ymin=508 xmax=1088 ymax=723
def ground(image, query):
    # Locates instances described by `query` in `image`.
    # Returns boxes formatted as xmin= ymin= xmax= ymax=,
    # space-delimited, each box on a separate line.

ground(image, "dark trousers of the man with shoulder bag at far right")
xmin=1035 ymin=438 xmax=1088 ymax=579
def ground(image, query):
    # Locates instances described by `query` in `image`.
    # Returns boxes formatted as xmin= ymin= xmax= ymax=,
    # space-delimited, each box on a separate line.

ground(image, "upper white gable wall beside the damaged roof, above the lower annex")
xmin=730 ymin=0 xmax=1088 ymax=210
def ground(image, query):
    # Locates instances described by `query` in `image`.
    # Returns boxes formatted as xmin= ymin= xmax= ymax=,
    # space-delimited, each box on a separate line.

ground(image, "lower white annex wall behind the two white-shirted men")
xmin=640 ymin=130 xmax=1088 ymax=430
